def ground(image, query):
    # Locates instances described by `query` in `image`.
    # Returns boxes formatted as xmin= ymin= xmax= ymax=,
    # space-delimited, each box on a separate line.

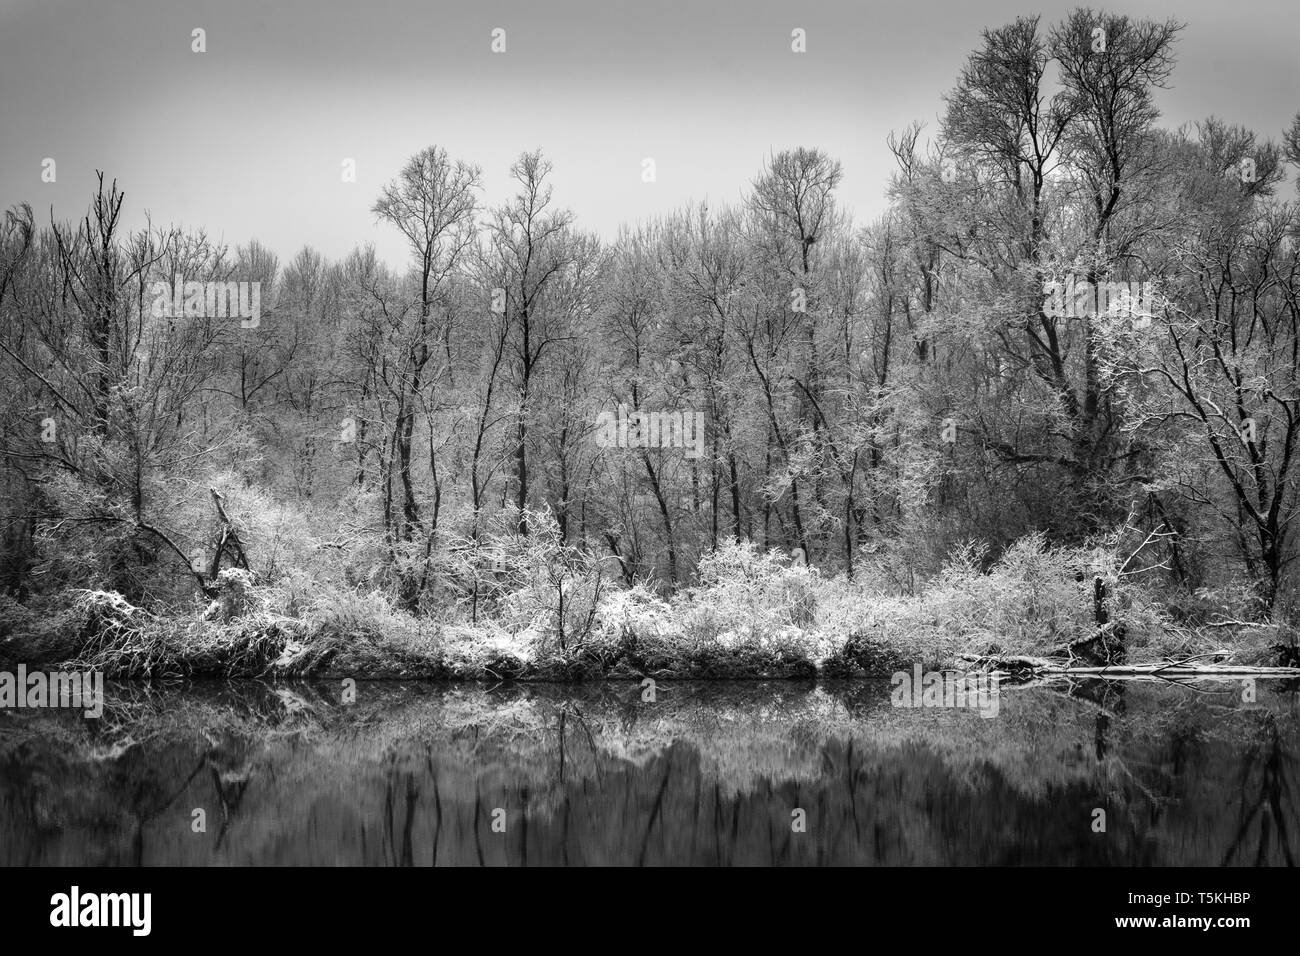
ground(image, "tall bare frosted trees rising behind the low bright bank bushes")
xmin=0 ymin=10 xmax=1300 ymax=624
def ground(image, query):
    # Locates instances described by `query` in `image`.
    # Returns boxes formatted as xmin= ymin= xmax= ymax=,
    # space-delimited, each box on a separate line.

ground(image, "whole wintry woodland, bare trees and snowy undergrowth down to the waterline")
xmin=0 ymin=10 xmax=1300 ymax=679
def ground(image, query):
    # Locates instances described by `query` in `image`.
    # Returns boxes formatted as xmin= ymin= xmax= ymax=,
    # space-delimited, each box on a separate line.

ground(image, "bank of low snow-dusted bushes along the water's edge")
xmin=0 ymin=545 xmax=1296 ymax=683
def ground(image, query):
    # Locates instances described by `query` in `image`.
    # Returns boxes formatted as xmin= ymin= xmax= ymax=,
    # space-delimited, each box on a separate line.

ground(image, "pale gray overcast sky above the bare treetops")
xmin=0 ymin=0 xmax=1300 ymax=269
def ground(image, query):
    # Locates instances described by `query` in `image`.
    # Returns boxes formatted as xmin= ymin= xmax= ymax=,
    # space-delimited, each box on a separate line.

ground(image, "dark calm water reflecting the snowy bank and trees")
xmin=0 ymin=682 xmax=1300 ymax=866
